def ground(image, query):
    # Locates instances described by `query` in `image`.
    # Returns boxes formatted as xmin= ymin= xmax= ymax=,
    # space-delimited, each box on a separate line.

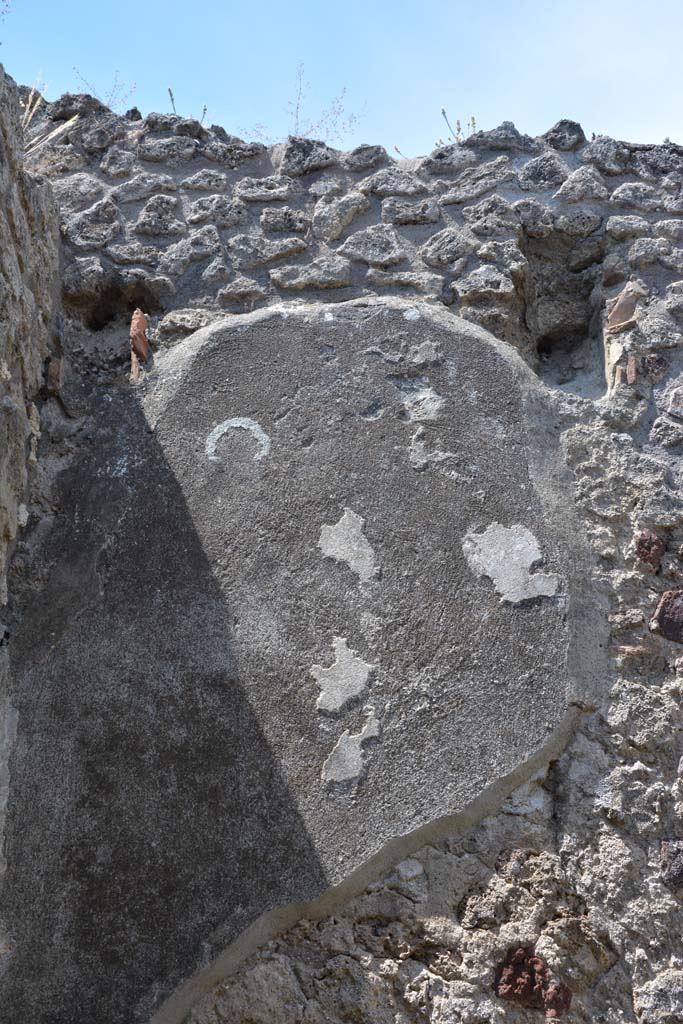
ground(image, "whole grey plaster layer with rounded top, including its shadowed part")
xmin=0 ymin=301 xmax=602 ymax=1024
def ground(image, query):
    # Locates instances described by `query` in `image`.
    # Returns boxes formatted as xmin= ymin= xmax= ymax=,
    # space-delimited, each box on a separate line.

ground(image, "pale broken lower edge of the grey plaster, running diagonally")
xmin=150 ymin=703 xmax=584 ymax=1024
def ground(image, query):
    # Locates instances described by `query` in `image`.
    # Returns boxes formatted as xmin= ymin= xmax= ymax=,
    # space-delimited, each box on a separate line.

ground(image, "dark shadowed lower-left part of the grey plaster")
xmin=0 ymin=390 xmax=326 ymax=1024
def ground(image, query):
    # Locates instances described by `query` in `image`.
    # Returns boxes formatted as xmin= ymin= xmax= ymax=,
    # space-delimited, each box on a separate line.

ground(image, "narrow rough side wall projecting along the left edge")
xmin=0 ymin=66 xmax=59 ymax=983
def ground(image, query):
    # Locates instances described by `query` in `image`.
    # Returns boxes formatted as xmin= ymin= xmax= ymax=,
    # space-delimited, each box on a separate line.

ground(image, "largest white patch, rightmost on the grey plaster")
xmin=463 ymin=522 xmax=560 ymax=604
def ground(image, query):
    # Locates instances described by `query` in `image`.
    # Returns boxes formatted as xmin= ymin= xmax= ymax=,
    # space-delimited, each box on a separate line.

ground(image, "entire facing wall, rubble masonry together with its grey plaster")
xmin=0 ymin=86 xmax=683 ymax=1024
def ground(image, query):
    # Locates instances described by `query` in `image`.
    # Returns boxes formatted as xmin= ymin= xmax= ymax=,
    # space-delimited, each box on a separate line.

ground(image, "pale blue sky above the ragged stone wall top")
xmin=0 ymin=0 xmax=683 ymax=157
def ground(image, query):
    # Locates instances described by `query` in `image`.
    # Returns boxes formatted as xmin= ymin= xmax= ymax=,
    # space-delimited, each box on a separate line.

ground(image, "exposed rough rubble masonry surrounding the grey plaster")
xmin=6 ymin=88 xmax=683 ymax=1024
